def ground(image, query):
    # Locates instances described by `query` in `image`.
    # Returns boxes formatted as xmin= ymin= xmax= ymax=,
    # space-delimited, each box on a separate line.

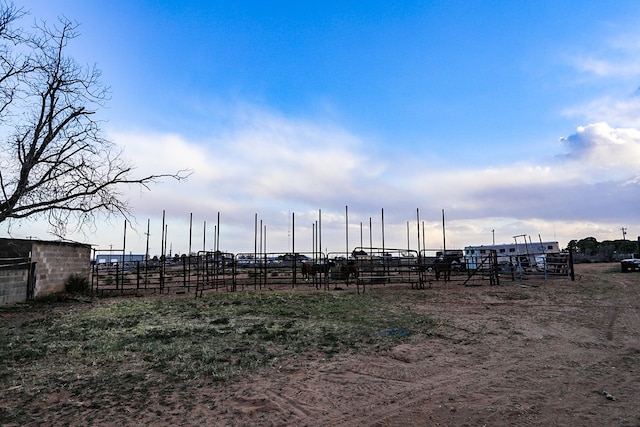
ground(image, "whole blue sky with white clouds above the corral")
xmin=5 ymin=0 xmax=640 ymax=252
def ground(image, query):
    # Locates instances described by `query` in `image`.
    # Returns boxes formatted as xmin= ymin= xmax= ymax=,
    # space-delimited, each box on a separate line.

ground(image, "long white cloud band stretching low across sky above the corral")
xmin=6 ymin=105 xmax=640 ymax=252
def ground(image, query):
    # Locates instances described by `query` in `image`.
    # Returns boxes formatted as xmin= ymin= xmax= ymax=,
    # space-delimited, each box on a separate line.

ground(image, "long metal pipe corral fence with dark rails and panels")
xmin=91 ymin=247 xmax=573 ymax=297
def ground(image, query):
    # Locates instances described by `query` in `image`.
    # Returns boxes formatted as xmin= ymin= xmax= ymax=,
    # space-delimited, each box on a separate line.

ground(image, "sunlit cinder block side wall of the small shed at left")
xmin=31 ymin=242 xmax=91 ymax=298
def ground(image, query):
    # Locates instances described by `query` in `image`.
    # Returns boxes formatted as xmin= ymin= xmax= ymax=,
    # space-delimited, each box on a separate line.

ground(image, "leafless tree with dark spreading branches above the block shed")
xmin=0 ymin=3 xmax=188 ymax=235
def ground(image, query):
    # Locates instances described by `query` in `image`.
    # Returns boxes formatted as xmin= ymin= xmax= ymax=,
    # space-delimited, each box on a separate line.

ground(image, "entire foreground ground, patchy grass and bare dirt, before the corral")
xmin=0 ymin=264 xmax=640 ymax=426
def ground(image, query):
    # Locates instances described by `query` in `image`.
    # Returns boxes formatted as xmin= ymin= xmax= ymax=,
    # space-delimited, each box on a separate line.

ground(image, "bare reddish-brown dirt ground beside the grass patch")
xmin=3 ymin=264 xmax=640 ymax=426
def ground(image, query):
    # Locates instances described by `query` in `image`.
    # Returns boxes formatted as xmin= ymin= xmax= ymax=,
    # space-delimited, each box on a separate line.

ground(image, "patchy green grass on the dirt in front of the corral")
xmin=0 ymin=291 xmax=437 ymax=423
